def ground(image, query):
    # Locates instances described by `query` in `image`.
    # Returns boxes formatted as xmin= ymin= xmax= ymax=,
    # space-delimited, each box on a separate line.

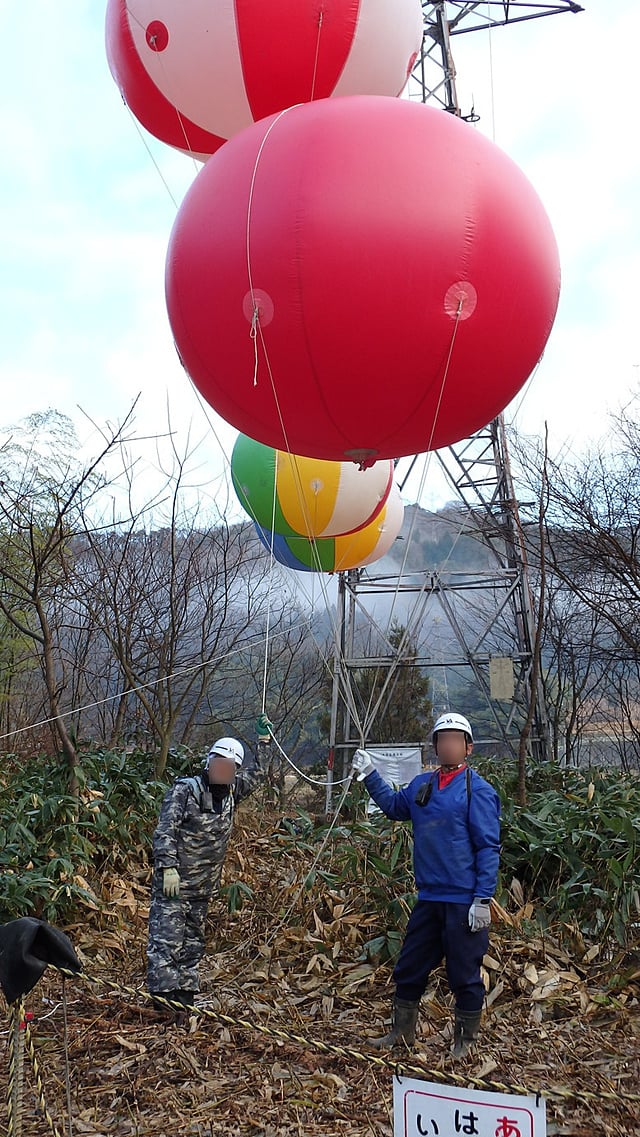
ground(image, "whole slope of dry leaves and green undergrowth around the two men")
xmin=0 ymin=752 xmax=640 ymax=1137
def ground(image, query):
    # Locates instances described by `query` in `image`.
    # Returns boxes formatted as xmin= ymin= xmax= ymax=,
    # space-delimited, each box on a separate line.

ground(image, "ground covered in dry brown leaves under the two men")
xmin=0 ymin=812 xmax=640 ymax=1137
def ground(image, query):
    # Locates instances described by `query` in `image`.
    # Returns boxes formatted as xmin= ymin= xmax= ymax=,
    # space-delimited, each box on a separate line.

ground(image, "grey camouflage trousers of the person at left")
xmin=147 ymin=872 xmax=209 ymax=994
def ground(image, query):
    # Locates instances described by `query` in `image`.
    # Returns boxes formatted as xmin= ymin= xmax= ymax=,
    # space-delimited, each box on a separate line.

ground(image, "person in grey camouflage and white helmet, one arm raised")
xmin=147 ymin=715 xmax=271 ymax=1009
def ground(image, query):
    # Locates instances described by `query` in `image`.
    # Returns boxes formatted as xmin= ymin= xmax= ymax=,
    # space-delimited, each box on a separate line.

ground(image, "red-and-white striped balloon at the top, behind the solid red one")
xmin=107 ymin=0 xmax=423 ymax=159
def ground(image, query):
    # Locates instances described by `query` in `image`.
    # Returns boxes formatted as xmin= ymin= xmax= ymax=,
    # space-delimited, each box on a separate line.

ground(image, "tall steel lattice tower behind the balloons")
xmin=326 ymin=0 xmax=582 ymax=812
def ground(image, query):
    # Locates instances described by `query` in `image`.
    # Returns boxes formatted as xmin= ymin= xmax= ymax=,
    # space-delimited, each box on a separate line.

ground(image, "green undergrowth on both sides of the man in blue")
xmin=272 ymin=758 xmax=640 ymax=960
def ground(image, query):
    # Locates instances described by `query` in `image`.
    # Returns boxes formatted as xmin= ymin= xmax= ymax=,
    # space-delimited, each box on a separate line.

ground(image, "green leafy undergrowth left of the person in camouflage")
xmin=0 ymin=750 xmax=166 ymax=922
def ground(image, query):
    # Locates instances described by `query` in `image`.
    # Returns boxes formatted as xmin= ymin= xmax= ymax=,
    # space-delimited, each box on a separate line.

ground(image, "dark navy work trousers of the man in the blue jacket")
xmin=393 ymin=901 xmax=489 ymax=1012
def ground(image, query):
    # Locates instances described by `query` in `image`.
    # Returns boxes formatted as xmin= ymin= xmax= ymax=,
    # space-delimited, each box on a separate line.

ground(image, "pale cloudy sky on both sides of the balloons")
xmin=0 ymin=0 xmax=640 ymax=507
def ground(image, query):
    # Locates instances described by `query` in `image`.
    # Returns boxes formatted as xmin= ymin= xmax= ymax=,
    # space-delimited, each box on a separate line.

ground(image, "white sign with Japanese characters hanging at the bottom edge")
xmin=393 ymin=1078 xmax=547 ymax=1137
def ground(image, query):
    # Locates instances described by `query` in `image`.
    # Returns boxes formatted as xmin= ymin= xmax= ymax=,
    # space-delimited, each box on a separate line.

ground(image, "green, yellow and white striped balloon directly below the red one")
xmin=231 ymin=434 xmax=393 ymax=538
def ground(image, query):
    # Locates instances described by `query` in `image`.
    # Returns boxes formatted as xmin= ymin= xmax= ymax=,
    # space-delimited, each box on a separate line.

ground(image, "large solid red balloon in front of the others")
xmin=166 ymin=97 xmax=559 ymax=460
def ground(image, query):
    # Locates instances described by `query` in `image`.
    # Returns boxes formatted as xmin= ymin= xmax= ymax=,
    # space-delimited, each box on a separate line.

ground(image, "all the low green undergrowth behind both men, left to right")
xmin=0 ymin=750 xmax=640 ymax=962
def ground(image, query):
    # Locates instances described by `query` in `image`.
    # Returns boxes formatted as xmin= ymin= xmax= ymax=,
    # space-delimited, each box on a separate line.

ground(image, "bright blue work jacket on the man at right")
xmin=365 ymin=770 xmax=500 ymax=904
